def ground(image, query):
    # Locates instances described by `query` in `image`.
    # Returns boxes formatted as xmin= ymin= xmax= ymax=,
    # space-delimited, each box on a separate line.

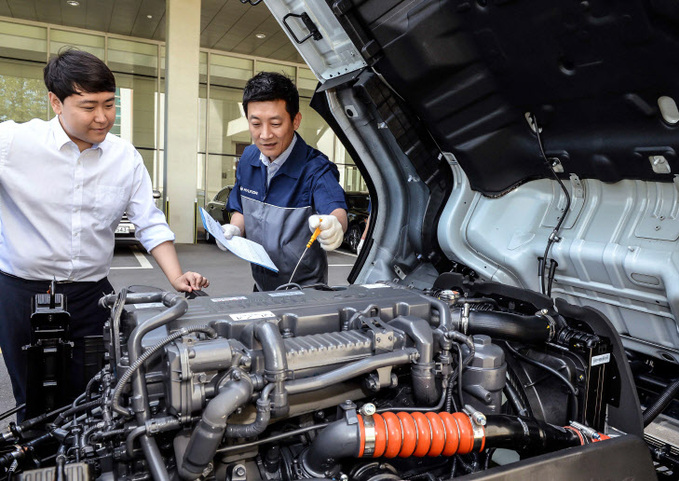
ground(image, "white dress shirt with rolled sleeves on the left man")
xmin=0 ymin=117 xmax=174 ymax=281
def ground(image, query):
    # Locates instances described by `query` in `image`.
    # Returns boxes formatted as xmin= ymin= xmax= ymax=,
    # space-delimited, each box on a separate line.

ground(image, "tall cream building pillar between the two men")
xmin=163 ymin=0 xmax=200 ymax=243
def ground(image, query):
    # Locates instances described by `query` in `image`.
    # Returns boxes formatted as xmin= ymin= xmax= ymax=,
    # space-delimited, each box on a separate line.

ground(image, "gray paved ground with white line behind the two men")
xmin=0 ymin=243 xmax=356 ymax=428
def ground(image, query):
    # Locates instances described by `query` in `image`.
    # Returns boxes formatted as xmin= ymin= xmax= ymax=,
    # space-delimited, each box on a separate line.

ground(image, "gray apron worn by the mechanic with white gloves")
xmin=241 ymin=196 xmax=328 ymax=291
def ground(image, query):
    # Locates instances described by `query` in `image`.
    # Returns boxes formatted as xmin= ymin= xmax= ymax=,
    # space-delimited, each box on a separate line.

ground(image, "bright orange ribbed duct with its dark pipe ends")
xmin=301 ymin=412 xmax=606 ymax=477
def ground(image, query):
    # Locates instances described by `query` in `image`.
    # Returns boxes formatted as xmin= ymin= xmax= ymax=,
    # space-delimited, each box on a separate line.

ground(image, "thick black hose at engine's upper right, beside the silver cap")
xmin=468 ymin=311 xmax=554 ymax=344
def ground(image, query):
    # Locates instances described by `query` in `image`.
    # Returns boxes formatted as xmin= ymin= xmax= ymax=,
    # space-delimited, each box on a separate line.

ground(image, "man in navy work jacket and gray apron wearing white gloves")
xmin=220 ymin=72 xmax=347 ymax=291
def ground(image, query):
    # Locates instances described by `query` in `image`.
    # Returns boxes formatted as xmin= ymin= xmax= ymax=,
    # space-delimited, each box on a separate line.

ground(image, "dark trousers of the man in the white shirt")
xmin=0 ymin=272 xmax=113 ymax=419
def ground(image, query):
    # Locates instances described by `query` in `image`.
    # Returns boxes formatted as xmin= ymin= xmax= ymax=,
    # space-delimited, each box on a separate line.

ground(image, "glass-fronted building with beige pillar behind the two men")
xmin=0 ymin=0 xmax=366 ymax=243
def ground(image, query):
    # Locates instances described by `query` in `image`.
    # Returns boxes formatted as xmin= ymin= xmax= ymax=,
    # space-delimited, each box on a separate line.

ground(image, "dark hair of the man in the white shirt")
xmin=44 ymin=48 xmax=116 ymax=102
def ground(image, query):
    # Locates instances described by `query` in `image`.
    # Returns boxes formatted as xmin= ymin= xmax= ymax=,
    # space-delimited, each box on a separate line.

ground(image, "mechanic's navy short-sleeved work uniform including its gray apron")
xmin=227 ymin=134 xmax=347 ymax=290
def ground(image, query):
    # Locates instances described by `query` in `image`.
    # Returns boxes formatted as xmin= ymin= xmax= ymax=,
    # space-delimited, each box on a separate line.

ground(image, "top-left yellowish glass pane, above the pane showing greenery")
xmin=0 ymin=22 xmax=47 ymax=62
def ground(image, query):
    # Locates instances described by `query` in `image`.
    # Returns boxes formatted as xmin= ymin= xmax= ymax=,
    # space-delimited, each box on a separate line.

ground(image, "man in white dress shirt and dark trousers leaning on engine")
xmin=0 ymin=50 xmax=209 ymax=414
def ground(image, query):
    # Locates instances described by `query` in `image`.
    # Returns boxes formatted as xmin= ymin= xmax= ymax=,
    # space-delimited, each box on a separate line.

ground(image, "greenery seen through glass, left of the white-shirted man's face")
xmin=0 ymin=75 xmax=47 ymax=122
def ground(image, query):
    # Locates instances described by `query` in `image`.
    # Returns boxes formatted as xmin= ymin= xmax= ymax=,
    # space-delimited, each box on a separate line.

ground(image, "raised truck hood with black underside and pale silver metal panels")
xmin=265 ymin=0 xmax=679 ymax=479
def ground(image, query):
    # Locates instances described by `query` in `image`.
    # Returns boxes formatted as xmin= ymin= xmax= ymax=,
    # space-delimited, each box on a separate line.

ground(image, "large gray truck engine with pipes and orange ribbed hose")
xmin=0 ymin=280 xmax=654 ymax=481
